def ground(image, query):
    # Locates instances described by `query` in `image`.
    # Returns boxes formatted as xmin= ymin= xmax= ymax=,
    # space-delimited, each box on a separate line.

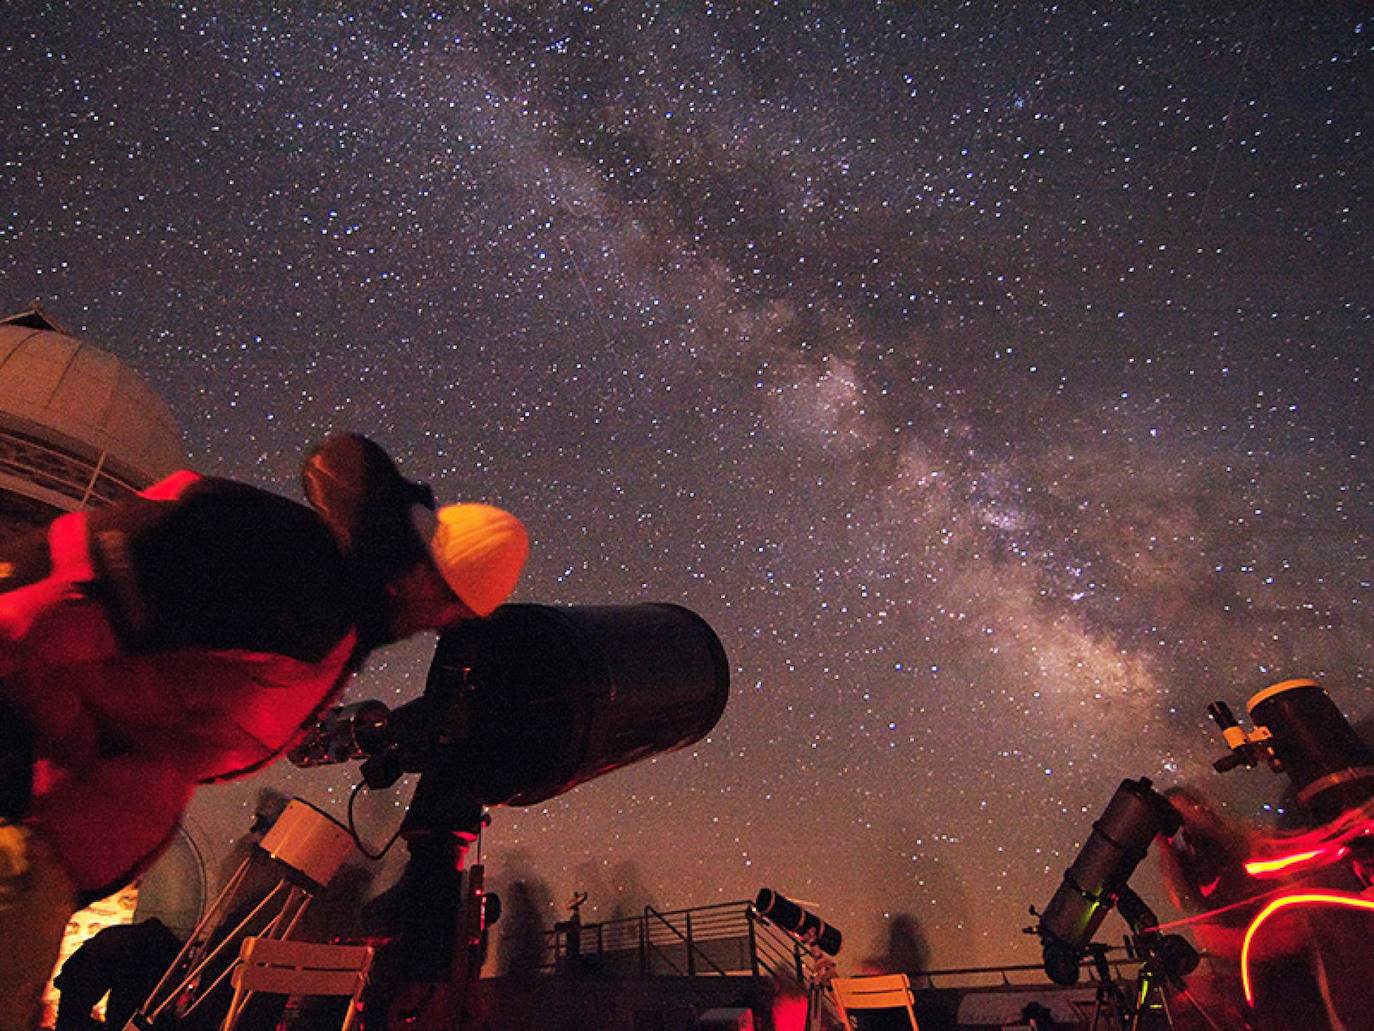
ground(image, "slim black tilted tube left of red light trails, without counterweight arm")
xmin=1037 ymin=777 xmax=1183 ymax=986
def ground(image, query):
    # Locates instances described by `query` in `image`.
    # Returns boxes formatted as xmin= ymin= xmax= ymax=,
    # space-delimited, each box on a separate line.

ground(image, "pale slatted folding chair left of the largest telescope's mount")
xmin=223 ymin=938 xmax=372 ymax=1031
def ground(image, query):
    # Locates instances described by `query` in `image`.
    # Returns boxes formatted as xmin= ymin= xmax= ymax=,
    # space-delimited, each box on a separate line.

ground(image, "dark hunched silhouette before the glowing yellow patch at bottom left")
xmin=55 ymin=918 xmax=181 ymax=1031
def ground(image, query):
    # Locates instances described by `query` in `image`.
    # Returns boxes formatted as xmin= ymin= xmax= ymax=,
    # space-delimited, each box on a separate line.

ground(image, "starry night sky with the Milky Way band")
xmin=0 ymin=0 xmax=1374 ymax=965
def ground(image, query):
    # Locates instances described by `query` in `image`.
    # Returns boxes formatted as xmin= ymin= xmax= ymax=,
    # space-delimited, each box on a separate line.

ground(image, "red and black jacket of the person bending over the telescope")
xmin=0 ymin=472 xmax=359 ymax=895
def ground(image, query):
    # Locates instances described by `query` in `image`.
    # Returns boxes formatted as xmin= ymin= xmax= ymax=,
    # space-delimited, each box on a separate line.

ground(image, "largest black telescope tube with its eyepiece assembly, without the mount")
xmin=289 ymin=603 xmax=730 ymax=830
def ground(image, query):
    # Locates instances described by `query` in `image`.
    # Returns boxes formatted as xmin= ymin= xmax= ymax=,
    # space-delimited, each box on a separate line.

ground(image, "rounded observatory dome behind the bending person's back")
xmin=0 ymin=304 xmax=185 ymax=537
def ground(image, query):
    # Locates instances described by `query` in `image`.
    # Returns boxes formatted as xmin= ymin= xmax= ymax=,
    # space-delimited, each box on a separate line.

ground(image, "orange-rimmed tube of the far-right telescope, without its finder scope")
xmin=1246 ymin=679 xmax=1374 ymax=823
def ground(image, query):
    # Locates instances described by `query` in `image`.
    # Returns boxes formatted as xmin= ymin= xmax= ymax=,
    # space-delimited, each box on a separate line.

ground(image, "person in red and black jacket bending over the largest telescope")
xmin=0 ymin=434 xmax=528 ymax=1028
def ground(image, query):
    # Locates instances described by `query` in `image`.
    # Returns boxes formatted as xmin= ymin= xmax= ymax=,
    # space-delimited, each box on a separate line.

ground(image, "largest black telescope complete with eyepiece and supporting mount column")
xmin=290 ymin=605 xmax=730 ymax=1031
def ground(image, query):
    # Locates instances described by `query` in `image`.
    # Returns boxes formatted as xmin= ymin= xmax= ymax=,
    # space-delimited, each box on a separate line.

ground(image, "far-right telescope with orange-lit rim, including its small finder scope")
xmin=1208 ymin=679 xmax=1374 ymax=823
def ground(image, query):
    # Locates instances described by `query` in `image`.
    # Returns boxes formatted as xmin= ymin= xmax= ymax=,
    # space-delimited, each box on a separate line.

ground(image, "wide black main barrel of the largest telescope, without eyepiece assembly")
xmin=425 ymin=605 xmax=730 ymax=806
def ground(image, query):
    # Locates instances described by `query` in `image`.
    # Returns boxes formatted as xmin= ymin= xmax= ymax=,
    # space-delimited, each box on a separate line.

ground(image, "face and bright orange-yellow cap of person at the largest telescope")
xmin=386 ymin=503 xmax=529 ymax=639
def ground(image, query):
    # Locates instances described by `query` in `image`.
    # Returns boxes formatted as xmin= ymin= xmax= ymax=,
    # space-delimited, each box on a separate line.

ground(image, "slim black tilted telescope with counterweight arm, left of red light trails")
xmin=1032 ymin=777 xmax=1198 ymax=986
